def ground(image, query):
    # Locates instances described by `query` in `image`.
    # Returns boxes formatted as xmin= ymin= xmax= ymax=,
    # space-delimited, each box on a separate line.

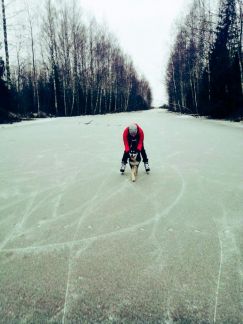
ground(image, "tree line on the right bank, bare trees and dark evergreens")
xmin=166 ymin=0 xmax=243 ymax=119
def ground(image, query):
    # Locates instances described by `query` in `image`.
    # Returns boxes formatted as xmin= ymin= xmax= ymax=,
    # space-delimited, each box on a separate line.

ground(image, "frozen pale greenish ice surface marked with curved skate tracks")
xmin=0 ymin=110 xmax=243 ymax=323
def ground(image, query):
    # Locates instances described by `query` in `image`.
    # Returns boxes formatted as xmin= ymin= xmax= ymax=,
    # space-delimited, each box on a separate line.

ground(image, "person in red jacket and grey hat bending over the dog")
xmin=120 ymin=123 xmax=150 ymax=173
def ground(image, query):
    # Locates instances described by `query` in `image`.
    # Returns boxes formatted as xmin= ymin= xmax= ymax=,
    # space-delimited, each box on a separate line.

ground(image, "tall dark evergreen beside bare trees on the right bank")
xmin=209 ymin=0 xmax=240 ymax=118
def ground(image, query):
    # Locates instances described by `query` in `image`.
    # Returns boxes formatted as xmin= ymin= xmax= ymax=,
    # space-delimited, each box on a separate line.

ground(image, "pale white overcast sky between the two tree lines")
xmin=80 ymin=0 xmax=190 ymax=106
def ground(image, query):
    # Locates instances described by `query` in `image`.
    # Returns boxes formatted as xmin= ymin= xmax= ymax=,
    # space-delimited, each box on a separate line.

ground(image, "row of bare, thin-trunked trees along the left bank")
xmin=0 ymin=0 xmax=152 ymax=123
